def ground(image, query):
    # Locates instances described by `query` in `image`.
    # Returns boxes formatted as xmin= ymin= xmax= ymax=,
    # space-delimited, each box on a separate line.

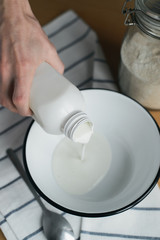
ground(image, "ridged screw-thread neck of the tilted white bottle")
xmin=62 ymin=111 xmax=93 ymax=144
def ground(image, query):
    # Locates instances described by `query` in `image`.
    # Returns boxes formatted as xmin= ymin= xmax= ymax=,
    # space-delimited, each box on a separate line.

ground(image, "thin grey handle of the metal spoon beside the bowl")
xmin=6 ymin=149 xmax=46 ymax=209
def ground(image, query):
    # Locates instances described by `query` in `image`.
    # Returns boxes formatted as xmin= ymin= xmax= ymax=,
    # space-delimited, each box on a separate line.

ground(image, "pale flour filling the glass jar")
xmin=119 ymin=27 xmax=160 ymax=109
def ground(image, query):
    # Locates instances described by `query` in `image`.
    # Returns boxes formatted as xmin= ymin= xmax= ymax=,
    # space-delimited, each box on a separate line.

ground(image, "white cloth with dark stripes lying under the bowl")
xmin=0 ymin=11 xmax=160 ymax=240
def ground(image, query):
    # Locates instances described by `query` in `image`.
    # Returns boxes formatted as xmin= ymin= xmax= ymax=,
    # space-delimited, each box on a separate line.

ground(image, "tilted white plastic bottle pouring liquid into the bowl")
xmin=30 ymin=62 xmax=93 ymax=143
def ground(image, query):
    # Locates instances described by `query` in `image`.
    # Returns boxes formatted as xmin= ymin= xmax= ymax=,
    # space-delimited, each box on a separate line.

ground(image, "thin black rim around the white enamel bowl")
xmin=23 ymin=88 xmax=160 ymax=217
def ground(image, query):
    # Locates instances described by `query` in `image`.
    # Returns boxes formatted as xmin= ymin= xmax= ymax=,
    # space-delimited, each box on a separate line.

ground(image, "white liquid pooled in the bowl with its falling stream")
xmin=53 ymin=133 xmax=111 ymax=195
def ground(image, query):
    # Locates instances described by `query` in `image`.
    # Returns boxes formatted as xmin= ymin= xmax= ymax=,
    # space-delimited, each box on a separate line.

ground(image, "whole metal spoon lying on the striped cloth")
xmin=7 ymin=149 xmax=75 ymax=240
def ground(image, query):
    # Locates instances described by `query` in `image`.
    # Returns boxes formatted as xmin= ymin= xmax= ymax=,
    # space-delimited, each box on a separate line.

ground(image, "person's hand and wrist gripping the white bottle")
xmin=0 ymin=0 xmax=64 ymax=116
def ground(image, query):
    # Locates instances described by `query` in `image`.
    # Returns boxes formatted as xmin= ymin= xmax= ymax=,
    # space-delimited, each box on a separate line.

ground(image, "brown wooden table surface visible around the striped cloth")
xmin=0 ymin=0 xmax=160 ymax=240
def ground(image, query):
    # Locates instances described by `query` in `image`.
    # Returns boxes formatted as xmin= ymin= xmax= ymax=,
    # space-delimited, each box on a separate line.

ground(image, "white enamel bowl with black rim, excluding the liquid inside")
xmin=24 ymin=89 xmax=160 ymax=217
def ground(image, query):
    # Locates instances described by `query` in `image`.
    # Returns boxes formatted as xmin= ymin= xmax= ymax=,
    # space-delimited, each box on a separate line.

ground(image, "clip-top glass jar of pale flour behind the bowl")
xmin=119 ymin=0 xmax=160 ymax=110
